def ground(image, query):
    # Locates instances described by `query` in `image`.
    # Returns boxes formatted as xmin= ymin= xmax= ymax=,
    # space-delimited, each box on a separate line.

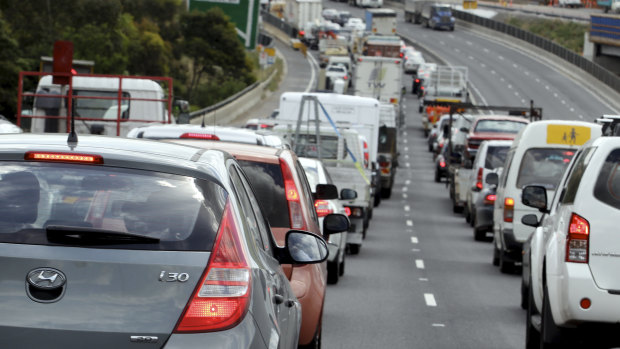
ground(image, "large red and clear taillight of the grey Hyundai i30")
xmin=174 ymin=203 xmax=251 ymax=333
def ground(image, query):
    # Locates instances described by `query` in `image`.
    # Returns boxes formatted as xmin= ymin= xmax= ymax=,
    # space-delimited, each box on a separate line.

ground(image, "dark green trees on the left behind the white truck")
xmin=0 ymin=0 xmax=256 ymax=116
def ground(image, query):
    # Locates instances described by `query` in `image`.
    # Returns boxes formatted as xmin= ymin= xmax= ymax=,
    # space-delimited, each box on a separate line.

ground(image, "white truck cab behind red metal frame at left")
xmin=29 ymin=75 xmax=174 ymax=136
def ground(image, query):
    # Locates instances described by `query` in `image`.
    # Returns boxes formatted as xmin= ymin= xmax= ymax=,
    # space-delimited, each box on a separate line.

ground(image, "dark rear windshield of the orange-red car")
xmin=239 ymin=160 xmax=291 ymax=228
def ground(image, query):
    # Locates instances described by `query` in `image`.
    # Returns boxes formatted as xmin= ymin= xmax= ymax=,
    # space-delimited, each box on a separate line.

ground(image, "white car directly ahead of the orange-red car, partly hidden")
xmin=299 ymin=157 xmax=352 ymax=284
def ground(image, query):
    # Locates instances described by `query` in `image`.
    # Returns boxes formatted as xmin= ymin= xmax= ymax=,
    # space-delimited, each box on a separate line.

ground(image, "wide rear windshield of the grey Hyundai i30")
xmin=0 ymin=162 xmax=227 ymax=251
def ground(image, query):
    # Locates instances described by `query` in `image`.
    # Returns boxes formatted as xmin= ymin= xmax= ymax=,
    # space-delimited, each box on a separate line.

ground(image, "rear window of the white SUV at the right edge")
xmin=594 ymin=149 xmax=620 ymax=209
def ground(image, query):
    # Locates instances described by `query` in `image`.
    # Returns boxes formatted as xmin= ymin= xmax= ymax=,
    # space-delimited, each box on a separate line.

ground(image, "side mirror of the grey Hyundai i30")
xmin=281 ymin=230 xmax=329 ymax=264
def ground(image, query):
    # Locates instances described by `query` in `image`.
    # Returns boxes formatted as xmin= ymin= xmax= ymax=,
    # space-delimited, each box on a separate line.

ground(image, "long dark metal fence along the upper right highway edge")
xmin=453 ymin=10 xmax=620 ymax=92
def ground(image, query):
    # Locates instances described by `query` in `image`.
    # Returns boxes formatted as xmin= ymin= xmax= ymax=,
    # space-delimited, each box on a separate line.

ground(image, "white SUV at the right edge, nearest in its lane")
xmin=522 ymin=130 xmax=620 ymax=348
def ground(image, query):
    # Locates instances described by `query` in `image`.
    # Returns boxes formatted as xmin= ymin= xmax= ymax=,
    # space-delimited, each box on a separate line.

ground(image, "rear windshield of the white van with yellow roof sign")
xmin=517 ymin=148 xmax=575 ymax=190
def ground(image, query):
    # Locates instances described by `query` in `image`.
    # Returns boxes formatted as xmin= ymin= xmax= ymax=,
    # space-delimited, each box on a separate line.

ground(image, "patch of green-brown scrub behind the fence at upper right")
xmin=506 ymin=17 xmax=588 ymax=53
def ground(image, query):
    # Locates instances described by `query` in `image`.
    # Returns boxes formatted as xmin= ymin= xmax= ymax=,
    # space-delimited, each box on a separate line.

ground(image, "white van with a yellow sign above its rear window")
xmin=493 ymin=120 xmax=601 ymax=273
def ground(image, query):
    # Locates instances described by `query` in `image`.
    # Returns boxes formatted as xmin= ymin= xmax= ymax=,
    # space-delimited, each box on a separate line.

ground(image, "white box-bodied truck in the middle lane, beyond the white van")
xmin=353 ymin=56 xmax=403 ymax=119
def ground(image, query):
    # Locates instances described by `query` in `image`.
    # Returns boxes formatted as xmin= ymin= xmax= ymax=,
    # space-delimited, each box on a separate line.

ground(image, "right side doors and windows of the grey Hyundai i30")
xmin=230 ymin=165 xmax=301 ymax=348
